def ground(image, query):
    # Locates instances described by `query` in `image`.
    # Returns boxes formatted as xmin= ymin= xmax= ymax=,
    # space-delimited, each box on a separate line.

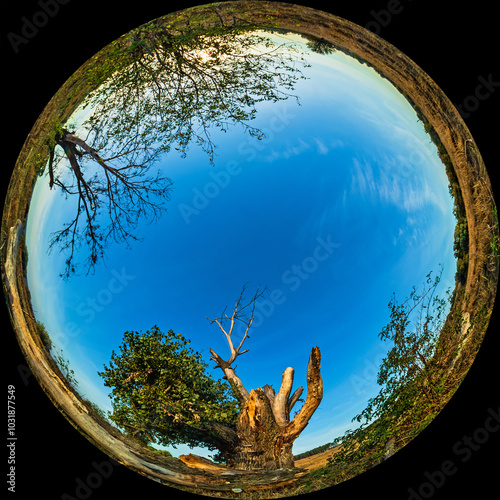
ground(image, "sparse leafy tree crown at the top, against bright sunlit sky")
xmin=80 ymin=20 xmax=308 ymax=163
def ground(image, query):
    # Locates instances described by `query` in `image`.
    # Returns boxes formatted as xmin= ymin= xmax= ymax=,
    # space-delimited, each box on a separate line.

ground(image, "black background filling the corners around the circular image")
xmin=0 ymin=0 xmax=500 ymax=500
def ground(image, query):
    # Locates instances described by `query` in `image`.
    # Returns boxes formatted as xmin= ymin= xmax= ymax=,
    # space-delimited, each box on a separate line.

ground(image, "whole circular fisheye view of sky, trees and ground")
xmin=0 ymin=1 xmax=499 ymax=498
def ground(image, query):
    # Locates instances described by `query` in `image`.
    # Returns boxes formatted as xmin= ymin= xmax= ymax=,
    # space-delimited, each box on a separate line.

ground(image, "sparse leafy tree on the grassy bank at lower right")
xmin=329 ymin=273 xmax=448 ymax=481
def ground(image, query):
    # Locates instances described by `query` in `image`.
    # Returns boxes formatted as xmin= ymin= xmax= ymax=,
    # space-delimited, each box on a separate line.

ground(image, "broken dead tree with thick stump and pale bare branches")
xmin=210 ymin=287 xmax=323 ymax=470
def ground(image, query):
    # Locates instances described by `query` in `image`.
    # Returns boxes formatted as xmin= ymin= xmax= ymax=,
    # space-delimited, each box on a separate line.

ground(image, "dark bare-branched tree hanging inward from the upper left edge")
xmin=49 ymin=129 xmax=172 ymax=278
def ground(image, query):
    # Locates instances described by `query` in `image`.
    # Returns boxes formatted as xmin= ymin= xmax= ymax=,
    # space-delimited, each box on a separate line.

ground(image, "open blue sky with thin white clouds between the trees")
xmin=27 ymin=35 xmax=455 ymax=454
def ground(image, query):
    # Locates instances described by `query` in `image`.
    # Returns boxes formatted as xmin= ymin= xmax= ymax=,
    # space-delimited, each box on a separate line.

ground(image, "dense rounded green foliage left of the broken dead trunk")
xmin=99 ymin=326 xmax=238 ymax=450
